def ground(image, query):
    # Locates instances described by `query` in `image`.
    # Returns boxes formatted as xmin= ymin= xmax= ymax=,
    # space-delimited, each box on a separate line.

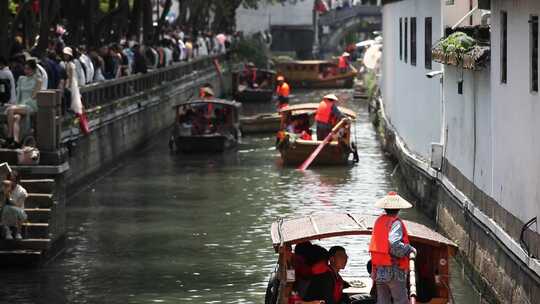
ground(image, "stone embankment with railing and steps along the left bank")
xmin=0 ymin=56 xmax=231 ymax=266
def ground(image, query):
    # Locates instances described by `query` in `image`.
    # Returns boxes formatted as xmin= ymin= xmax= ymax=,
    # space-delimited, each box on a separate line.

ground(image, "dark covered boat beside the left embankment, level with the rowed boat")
xmin=169 ymin=99 xmax=241 ymax=153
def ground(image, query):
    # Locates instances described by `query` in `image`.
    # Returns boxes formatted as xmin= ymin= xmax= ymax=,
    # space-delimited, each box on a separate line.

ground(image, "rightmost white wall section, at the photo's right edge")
xmin=491 ymin=0 xmax=540 ymax=228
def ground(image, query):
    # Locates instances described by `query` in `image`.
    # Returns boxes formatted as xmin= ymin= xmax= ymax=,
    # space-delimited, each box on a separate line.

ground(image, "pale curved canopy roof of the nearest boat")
xmin=271 ymin=213 xmax=457 ymax=252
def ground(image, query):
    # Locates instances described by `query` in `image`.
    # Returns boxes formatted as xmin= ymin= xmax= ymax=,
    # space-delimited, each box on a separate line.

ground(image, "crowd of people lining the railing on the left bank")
xmin=0 ymin=26 xmax=233 ymax=148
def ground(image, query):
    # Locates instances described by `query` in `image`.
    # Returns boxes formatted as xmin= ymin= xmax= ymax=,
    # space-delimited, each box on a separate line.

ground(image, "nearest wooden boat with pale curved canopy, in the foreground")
xmin=265 ymin=213 xmax=457 ymax=304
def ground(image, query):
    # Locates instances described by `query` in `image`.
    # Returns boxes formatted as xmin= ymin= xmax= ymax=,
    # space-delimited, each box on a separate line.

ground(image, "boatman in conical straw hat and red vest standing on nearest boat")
xmin=369 ymin=192 xmax=416 ymax=304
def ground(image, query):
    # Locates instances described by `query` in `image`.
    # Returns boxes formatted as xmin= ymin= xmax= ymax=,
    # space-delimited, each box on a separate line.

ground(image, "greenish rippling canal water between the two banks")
xmin=0 ymin=90 xmax=478 ymax=304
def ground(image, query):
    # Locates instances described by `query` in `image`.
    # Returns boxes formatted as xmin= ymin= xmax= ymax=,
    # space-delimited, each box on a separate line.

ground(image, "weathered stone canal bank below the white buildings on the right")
xmin=369 ymin=99 xmax=540 ymax=304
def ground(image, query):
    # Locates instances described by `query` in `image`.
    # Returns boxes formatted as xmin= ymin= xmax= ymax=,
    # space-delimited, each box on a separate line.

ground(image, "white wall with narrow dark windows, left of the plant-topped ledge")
xmin=382 ymin=0 xmax=441 ymax=159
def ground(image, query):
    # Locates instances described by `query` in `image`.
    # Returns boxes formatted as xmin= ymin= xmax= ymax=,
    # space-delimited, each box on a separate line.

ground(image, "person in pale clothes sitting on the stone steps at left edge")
xmin=0 ymin=171 xmax=28 ymax=240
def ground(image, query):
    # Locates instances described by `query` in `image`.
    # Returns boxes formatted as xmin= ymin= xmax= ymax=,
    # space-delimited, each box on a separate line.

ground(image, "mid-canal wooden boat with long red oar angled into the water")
xmin=277 ymin=103 xmax=358 ymax=166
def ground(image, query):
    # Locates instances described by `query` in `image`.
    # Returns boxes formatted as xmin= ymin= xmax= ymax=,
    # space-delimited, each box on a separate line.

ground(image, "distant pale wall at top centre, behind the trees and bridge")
xmin=236 ymin=0 xmax=313 ymax=34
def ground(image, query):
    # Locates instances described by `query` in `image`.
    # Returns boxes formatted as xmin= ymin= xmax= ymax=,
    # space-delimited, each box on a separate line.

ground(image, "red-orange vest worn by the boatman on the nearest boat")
xmin=369 ymin=214 xmax=409 ymax=271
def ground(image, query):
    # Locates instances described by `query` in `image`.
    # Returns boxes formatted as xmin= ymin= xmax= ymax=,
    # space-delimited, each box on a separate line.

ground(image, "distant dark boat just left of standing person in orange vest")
xmin=233 ymin=69 xmax=276 ymax=103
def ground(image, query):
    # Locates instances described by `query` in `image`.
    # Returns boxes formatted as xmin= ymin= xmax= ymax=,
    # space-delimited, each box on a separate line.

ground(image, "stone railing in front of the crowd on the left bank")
xmin=36 ymin=55 xmax=226 ymax=152
